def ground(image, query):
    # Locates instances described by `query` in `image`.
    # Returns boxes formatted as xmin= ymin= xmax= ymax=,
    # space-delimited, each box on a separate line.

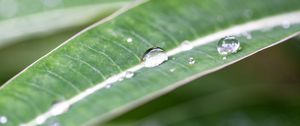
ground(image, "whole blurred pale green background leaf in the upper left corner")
xmin=0 ymin=0 xmax=129 ymax=47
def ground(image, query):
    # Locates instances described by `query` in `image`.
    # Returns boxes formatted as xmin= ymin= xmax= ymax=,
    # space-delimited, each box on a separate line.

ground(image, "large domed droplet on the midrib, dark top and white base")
xmin=142 ymin=47 xmax=168 ymax=67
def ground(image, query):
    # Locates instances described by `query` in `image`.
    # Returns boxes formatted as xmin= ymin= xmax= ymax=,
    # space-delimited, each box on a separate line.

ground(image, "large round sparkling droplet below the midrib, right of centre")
xmin=217 ymin=36 xmax=240 ymax=55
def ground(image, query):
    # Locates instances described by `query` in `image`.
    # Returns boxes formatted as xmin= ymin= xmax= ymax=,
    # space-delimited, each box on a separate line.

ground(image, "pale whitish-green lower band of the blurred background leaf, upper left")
xmin=0 ymin=1 xmax=128 ymax=48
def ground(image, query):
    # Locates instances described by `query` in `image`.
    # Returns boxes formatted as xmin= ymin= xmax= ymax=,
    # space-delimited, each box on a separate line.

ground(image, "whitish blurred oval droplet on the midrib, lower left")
xmin=50 ymin=101 xmax=70 ymax=116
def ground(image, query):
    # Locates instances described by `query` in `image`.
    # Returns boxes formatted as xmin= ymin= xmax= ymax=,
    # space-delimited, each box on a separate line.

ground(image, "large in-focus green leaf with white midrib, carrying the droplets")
xmin=0 ymin=0 xmax=300 ymax=126
